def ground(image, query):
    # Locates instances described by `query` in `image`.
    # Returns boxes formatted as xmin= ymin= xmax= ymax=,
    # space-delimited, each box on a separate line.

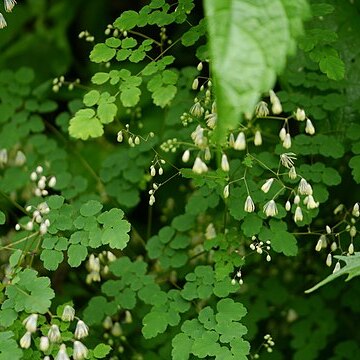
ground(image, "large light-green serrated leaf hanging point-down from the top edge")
xmin=204 ymin=0 xmax=309 ymax=142
